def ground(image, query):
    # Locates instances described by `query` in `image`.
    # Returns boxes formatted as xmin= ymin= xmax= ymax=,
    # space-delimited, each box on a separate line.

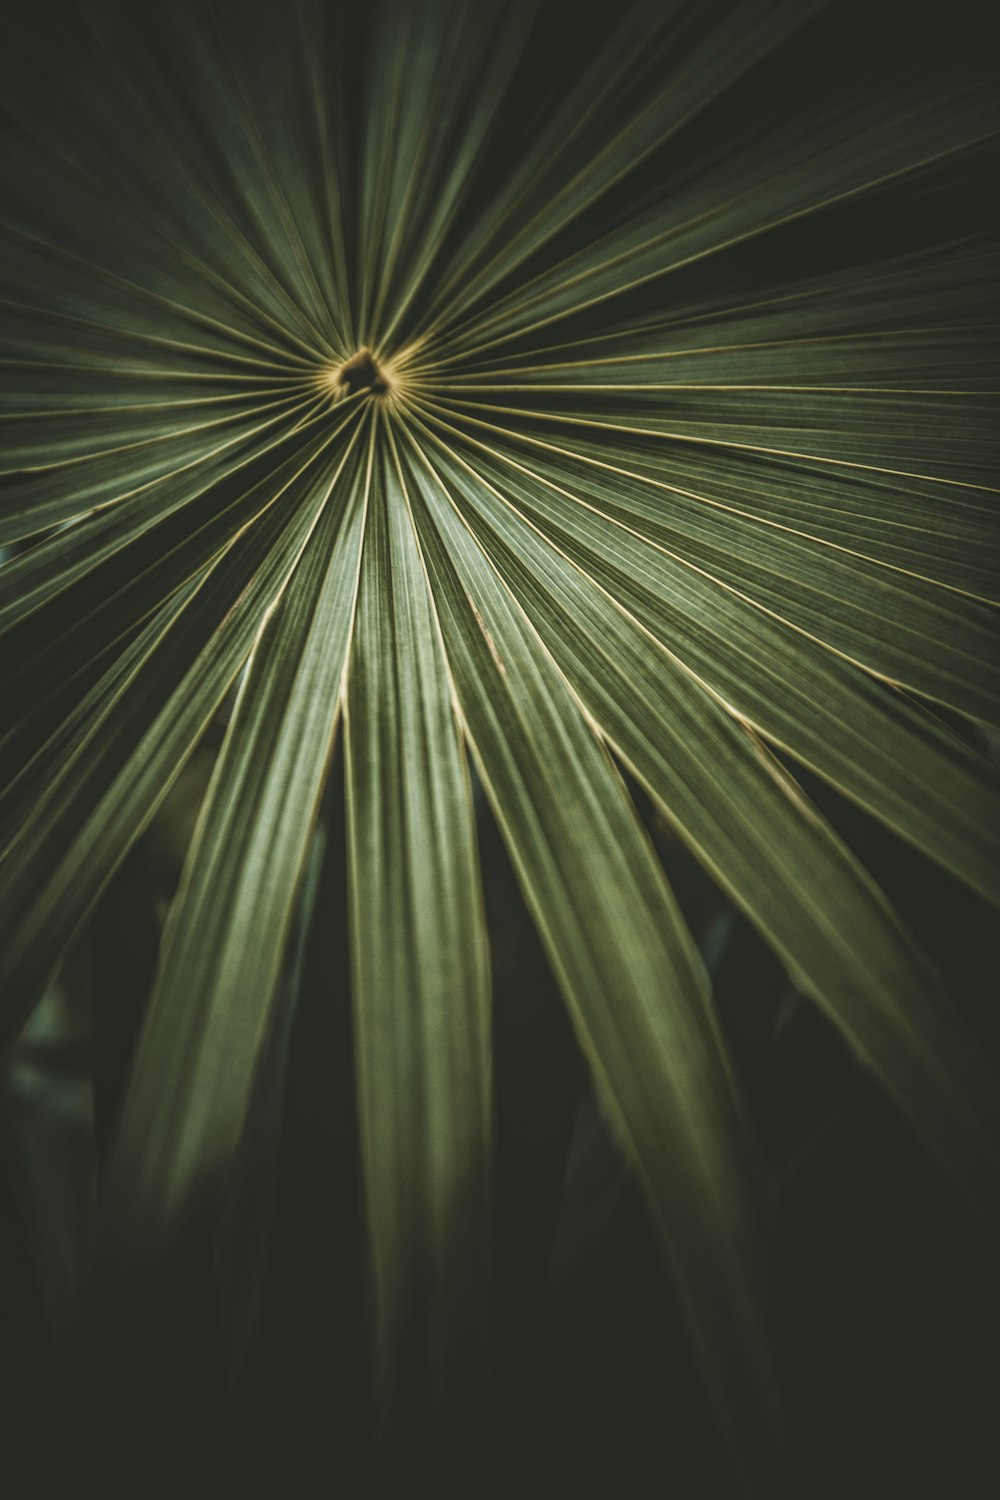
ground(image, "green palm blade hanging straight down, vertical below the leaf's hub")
xmin=345 ymin=423 xmax=492 ymax=1472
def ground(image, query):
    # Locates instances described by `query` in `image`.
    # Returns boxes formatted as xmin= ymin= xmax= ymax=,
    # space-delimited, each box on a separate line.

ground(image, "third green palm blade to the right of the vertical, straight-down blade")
xmin=416 ymin=402 xmax=1000 ymax=902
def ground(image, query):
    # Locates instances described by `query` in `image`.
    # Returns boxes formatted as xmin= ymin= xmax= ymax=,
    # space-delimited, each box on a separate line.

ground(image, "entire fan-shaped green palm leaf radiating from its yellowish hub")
xmin=0 ymin=3 xmax=1000 ymax=1494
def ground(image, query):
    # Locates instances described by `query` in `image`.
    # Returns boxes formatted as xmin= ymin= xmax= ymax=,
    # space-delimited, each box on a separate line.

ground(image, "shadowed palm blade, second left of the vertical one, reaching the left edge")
xmin=0 ymin=417 xmax=361 ymax=1037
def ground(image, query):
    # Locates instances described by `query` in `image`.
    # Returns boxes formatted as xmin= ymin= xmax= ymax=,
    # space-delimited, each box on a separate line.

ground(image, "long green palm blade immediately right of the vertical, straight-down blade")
xmin=398 ymin=420 xmax=780 ymax=1476
